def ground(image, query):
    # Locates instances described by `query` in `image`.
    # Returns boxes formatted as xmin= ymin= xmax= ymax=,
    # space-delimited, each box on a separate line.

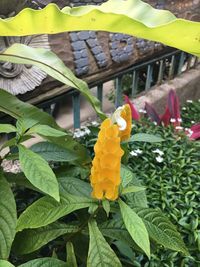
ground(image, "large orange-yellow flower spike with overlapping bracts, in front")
xmin=90 ymin=119 xmax=124 ymax=200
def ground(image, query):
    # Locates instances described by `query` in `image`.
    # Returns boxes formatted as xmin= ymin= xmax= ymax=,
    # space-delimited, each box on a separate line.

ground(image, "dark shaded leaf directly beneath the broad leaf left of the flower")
xmin=12 ymin=222 xmax=79 ymax=255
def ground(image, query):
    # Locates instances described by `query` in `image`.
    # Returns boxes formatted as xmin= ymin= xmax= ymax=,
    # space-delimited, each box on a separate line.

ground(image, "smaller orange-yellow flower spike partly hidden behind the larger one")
xmin=119 ymin=104 xmax=132 ymax=141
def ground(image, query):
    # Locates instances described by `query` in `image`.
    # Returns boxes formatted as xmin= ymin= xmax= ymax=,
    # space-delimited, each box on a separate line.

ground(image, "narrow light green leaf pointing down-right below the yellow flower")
xmin=119 ymin=199 xmax=150 ymax=258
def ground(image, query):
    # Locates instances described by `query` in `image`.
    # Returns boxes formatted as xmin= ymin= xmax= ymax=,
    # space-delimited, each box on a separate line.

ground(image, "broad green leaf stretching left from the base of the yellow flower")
xmin=17 ymin=191 xmax=96 ymax=231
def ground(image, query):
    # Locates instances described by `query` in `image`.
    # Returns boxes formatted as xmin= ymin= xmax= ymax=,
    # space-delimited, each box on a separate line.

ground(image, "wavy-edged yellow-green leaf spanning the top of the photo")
xmin=0 ymin=0 xmax=200 ymax=56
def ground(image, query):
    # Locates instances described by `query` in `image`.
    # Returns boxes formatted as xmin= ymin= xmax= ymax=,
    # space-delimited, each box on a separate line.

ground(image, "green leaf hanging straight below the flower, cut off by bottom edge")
xmin=87 ymin=220 xmax=122 ymax=267
